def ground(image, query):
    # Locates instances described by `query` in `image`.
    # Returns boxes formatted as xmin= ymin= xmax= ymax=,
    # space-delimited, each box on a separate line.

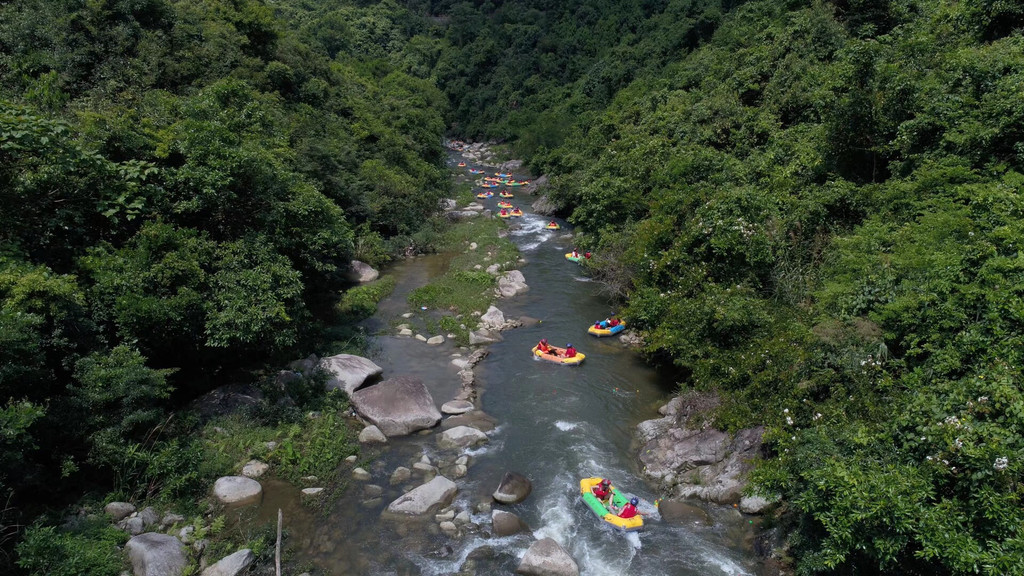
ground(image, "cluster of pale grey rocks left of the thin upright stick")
xmin=103 ymin=498 xmax=252 ymax=576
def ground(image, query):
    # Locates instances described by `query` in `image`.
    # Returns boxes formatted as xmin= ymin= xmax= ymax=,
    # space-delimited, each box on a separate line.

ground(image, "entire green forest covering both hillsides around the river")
xmin=0 ymin=0 xmax=1024 ymax=575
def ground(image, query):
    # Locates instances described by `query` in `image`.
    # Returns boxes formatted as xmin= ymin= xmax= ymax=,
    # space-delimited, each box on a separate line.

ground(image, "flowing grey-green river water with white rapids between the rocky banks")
xmin=256 ymin=154 xmax=761 ymax=576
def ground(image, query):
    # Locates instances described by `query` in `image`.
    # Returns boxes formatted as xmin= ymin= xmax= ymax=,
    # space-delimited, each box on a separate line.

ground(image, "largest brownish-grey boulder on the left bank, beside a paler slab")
xmin=351 ymin=376 xmax=441 ymax=438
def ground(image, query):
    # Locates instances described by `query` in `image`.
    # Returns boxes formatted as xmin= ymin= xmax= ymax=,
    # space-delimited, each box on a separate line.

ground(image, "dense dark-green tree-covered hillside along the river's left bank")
xmin=0 ymin=0 xmax=450 ymax=573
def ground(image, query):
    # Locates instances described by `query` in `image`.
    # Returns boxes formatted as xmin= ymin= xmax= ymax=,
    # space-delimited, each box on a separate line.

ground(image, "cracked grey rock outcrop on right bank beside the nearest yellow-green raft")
xmin=637 ymin=394 xmax=770 ymax=513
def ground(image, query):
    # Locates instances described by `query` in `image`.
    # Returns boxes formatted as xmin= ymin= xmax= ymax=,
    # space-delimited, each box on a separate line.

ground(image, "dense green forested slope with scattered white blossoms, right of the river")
xmin=438 ymin=0 xmax=1024 ymax=574
